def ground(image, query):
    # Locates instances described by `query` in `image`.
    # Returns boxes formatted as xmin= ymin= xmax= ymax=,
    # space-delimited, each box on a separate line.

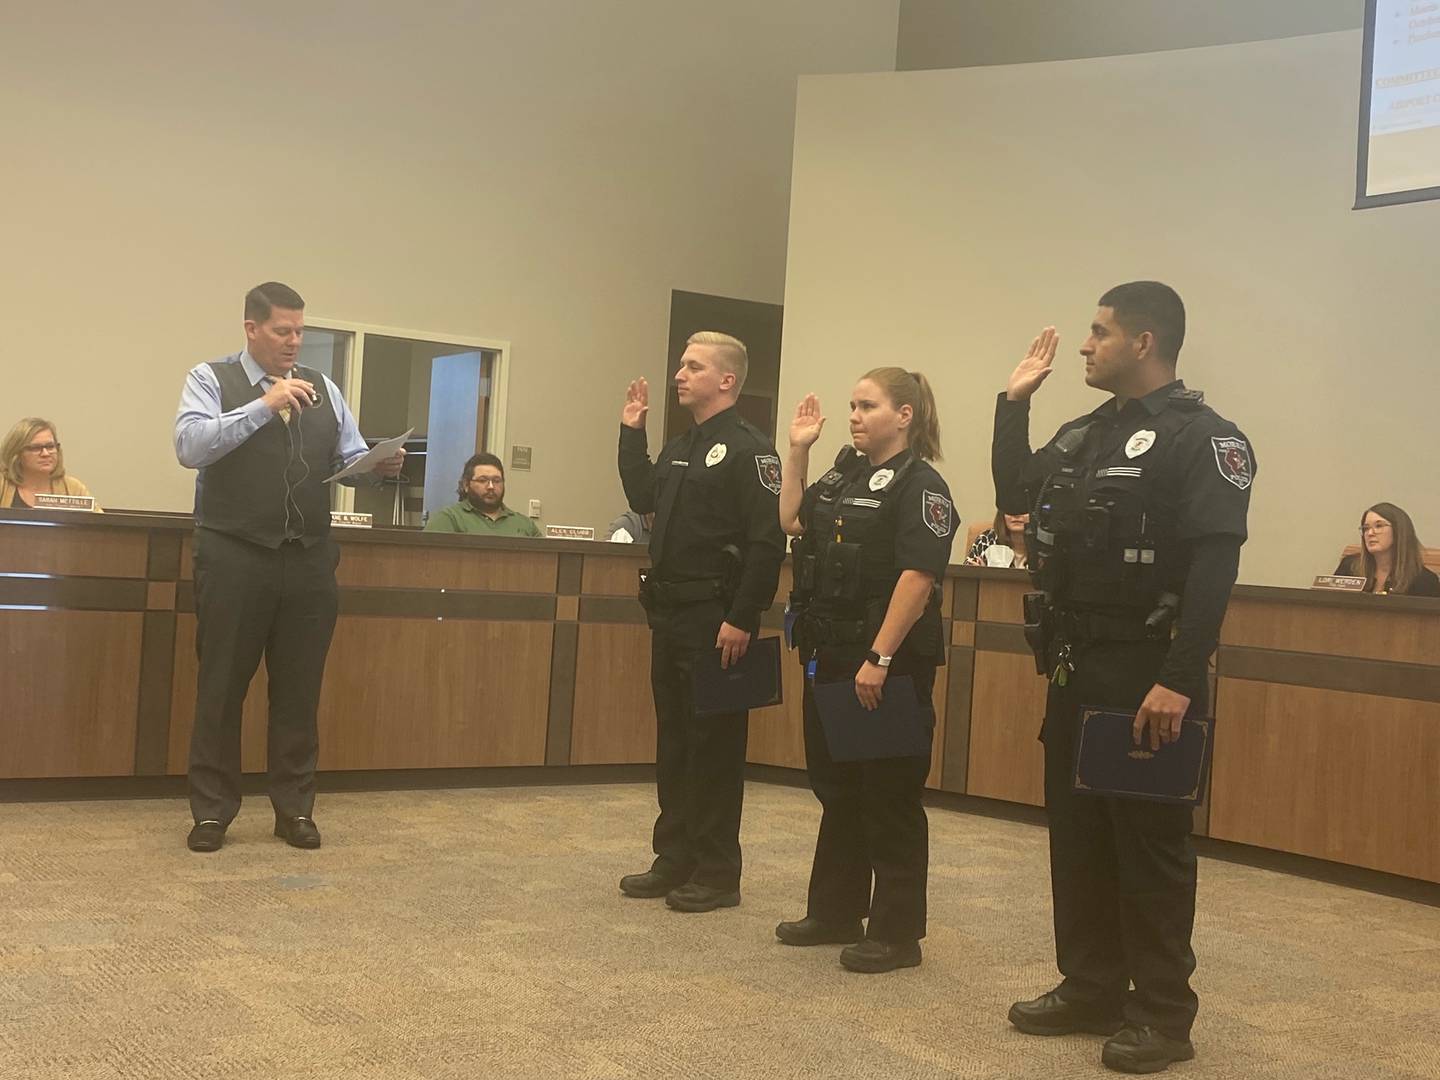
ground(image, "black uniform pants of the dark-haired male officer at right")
xmin=1044 ymin=642 xmax=1208 ymax=1038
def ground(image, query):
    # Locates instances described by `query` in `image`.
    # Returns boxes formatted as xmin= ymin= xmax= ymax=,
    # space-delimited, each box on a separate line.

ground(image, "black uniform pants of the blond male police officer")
xmin=649 ymin=600 xmax=750 ymax=891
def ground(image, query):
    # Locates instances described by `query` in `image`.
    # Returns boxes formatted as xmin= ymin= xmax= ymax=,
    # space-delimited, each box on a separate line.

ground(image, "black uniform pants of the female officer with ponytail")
xmin=805 ymin=662 xmax=935 ymax=945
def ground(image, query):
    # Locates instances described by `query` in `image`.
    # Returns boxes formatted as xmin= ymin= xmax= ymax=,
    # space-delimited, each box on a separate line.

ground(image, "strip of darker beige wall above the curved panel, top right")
xmin=896 ymin=0 xmax=1365 ymax=70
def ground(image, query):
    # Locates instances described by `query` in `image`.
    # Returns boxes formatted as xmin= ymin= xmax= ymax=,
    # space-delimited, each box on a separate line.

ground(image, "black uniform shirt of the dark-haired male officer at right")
xmin=991 ymin=380 xmax=1257 ymax=697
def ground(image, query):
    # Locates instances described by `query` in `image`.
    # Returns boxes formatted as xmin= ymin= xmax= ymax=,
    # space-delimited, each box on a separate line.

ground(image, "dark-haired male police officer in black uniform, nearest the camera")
xmin=991 ymin=281 xmax=1256 ymax=1073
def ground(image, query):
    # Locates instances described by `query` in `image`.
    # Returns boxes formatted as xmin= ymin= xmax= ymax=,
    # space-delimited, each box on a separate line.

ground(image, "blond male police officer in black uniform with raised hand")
xmin=619 ymin=331 xmax=785 ymax=912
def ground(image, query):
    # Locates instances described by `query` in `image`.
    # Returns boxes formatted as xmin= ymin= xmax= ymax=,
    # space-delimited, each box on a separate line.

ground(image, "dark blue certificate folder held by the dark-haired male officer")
xmin=1073 ymin=707 xmax=1215 ymax=806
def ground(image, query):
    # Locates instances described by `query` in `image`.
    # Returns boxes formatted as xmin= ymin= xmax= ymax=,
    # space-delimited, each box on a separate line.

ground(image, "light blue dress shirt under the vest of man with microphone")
xmin=176 ymin=350 xmax=377 ymax=484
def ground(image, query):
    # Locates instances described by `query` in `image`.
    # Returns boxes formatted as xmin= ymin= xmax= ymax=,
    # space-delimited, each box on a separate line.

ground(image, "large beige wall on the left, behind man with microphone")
xmin=0 ymin=0 xmax=899 ymax=526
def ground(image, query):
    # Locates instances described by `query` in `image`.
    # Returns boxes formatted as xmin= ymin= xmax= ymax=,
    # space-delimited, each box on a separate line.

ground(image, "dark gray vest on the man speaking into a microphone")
xmin=194 ymin=360 xmax=340 ymax=547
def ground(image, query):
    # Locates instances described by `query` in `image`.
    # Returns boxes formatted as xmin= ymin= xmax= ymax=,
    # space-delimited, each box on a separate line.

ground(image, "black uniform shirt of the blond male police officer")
xmin=619 ymin=406 xmax=785 ymax=634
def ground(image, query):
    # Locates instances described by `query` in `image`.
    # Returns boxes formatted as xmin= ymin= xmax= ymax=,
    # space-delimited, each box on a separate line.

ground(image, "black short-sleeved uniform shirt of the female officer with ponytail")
xmin=799 ymin=449 xmax=955 ymax=668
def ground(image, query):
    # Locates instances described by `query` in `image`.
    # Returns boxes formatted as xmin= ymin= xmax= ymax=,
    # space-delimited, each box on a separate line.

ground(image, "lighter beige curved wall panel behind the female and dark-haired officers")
xmin=780 ymin=32 xmax=1440 ymax=585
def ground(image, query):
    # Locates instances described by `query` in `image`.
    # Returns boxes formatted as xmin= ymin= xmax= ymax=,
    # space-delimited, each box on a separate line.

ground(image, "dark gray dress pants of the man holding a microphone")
xmin=190 ymin=528 xmax=340 ymax=825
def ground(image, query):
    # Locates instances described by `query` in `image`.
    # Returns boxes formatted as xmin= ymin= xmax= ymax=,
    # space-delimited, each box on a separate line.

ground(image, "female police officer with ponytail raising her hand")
xmin=775 ymin=367 xmax=955 ymax=972
